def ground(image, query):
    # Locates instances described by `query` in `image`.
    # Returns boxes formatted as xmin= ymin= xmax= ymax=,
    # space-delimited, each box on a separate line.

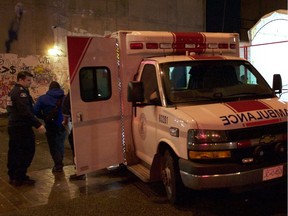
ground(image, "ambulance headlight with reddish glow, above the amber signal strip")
xmin=188 ymin=130 xmax=227 ymax=146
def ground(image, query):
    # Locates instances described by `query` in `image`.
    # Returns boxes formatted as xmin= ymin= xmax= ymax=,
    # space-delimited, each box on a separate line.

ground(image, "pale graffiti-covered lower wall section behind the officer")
xmin=0 ymin=53 xmax=69 ymax=113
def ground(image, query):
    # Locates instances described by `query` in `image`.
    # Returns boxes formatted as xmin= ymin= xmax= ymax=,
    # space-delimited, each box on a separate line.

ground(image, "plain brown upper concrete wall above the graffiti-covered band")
xmin=0 ymin=0 xmax=206 ymax=56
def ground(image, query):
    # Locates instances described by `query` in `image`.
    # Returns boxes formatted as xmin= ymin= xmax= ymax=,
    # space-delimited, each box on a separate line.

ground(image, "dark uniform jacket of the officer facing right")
xmin=7 ymin=84 xmax=41 ymax=128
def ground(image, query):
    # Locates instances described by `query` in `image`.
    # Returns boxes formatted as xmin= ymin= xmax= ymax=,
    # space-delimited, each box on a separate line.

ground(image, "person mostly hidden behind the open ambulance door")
xmin=62 ymin=92 xmax=86 ymax=181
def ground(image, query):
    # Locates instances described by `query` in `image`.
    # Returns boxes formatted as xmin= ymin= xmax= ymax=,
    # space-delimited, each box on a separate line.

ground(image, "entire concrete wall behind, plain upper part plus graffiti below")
xmin=0 ymin=0 xmax=206 ymax=113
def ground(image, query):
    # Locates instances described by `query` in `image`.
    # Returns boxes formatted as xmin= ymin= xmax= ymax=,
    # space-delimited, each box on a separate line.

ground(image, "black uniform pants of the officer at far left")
xmin=7 ymin=126 xmax=35 ymax=181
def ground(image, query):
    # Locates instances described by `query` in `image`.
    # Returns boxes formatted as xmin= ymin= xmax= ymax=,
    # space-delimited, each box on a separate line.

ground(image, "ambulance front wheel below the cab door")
xmin=161 ymin=150 xmax=182 ymax=204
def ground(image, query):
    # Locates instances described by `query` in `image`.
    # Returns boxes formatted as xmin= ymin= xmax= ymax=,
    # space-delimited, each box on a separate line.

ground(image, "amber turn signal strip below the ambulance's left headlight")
xmin=189 ymin=151 xmax=231 ymax=160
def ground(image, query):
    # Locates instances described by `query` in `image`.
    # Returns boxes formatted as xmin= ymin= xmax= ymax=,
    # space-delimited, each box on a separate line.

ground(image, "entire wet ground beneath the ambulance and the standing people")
xmin=0 ymin=115 xmax=287 ymax=216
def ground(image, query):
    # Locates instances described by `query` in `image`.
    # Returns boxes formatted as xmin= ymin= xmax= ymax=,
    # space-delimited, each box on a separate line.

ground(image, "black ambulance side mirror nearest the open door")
xmin=127 ymin=82 xmax=144 ymax=103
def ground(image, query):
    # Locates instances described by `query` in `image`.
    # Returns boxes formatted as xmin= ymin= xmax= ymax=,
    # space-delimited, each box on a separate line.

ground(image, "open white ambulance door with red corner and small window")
xmin=67 ymin=37 xmax=124 ymax=174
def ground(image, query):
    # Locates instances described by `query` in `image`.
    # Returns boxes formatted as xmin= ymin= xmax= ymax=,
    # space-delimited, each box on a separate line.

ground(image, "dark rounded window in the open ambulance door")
xmin=79 ymin=67 xmax=111 ymax=102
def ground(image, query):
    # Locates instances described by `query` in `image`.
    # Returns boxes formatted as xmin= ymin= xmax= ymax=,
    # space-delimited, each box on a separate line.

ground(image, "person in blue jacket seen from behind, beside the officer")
xmin=34 ymin=81 xmax=66 ymax=173
